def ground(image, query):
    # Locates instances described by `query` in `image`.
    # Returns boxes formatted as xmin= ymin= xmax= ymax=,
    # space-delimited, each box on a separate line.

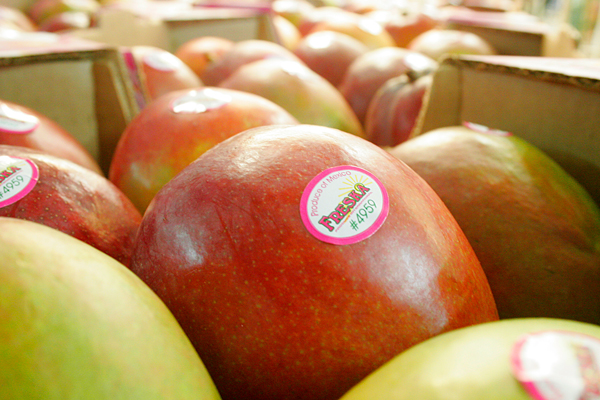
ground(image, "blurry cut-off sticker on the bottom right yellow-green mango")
xmin=511 ymin=331 xmax=600 ymax=400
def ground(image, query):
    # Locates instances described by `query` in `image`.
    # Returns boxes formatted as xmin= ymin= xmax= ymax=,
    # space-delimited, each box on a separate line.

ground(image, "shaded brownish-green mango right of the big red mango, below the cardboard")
xmin=390 ymin=126 xmax=600 ymax=324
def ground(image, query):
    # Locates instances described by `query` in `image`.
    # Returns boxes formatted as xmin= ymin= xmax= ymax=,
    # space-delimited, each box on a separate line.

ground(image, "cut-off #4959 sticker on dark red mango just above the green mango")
xmin=0 ymin=156 xmax=39 ymax=208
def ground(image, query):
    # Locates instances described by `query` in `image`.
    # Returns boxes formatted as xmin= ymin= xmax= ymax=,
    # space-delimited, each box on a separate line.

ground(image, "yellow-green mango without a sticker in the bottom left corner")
xmin=0 ymin=217 xmax=220 ymax=400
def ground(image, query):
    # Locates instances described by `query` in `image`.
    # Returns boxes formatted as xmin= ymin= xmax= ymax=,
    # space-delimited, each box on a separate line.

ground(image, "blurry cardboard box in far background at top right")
xmin=444 ymin=8 xmax=579 ymax=57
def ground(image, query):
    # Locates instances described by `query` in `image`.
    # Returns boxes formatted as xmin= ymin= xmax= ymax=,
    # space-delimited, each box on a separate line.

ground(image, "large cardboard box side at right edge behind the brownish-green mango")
xmin=413 ymin=56 xmax=600 ymax=204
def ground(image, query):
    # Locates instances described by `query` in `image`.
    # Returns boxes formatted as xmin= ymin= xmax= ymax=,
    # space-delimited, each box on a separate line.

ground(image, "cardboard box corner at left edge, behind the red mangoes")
xmin=0 ymin=33 xmax=139 ymax=171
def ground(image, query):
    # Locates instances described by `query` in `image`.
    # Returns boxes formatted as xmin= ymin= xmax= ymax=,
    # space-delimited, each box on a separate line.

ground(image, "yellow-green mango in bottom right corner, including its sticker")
xmin=340 ymin=318 xmax=600 ymax=400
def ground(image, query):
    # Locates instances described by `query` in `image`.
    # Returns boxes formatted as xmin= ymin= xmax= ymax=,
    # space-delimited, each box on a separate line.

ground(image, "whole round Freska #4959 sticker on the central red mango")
xmin=300 ymin=165 xmax=389 ymax=245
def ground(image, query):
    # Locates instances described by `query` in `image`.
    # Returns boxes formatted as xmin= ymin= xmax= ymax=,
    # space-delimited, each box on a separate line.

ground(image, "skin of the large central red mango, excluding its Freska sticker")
xmin=131 ymin=125 xmax=498 ymax=400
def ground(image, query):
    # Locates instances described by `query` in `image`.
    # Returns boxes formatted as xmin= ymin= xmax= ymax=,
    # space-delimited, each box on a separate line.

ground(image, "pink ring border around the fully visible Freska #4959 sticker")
xmin=300 ymin=165 xmax=390 ymax=245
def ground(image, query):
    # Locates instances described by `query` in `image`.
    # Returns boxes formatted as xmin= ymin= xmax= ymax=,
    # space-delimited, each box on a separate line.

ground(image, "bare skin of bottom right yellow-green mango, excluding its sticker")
xmin=340 ymin=318 xmax=600 ymax=400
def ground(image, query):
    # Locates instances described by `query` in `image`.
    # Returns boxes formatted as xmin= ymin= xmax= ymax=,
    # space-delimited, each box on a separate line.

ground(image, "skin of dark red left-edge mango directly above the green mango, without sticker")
xmin=0 ymin=145 xmax=142 ymax=265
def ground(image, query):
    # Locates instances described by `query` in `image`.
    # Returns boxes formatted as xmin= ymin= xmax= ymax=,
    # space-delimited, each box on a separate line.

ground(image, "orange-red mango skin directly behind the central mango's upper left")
xmin=108 ymin=87 xmax=298 ymax=213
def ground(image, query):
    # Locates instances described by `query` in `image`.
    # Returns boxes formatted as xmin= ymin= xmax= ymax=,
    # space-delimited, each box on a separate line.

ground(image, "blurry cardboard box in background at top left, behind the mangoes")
xmin=73 ymin=1 xmax=279 ymax=52
